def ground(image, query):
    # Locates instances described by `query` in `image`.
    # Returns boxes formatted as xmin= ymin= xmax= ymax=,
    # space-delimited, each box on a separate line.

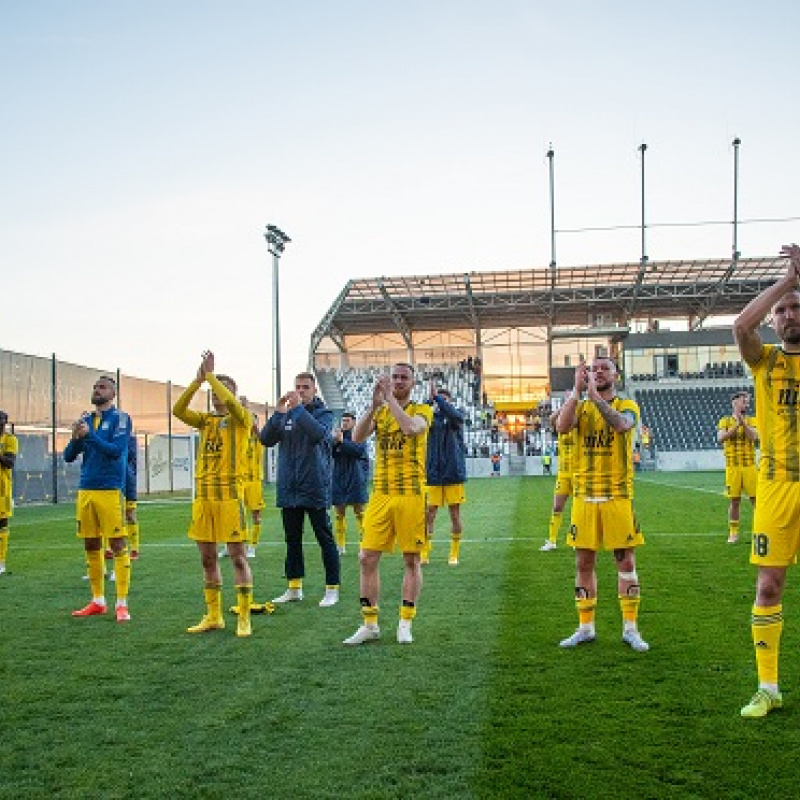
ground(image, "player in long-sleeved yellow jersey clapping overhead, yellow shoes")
xmin=172 ymin=350 xmax=253 ymax=637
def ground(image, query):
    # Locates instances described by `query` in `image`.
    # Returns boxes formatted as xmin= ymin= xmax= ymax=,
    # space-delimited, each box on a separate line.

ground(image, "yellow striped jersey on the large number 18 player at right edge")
xmin=752 ymin=344 xmax=800 ymax=481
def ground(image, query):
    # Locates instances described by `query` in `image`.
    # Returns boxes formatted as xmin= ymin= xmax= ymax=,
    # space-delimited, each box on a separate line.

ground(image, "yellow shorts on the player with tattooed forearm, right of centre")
xmin=567 ymin=497 xmax=644 ymax=550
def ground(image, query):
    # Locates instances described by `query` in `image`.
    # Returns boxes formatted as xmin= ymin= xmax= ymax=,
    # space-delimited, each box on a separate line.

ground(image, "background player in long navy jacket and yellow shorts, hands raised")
xmin=421 ymin=378 xmax=467 ymax=566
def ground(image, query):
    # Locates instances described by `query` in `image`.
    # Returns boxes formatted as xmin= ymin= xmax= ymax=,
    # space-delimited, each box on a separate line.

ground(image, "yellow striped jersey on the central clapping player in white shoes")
xmin=372 ymin=403 xmax=433 ymax=495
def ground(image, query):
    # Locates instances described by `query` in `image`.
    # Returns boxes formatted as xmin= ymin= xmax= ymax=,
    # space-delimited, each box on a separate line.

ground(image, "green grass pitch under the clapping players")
xmin=0 ymin=473 xmax=800 ymax=799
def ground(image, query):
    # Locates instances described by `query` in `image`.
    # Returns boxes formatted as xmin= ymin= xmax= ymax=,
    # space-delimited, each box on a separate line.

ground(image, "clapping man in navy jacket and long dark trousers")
xmin=260 ymin=372 xmax=339 ymax=608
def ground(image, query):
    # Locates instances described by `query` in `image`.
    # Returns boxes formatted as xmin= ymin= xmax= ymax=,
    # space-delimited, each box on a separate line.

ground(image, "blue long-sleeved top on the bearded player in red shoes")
xmin=64 ymin=406 xmax=133 ymax=491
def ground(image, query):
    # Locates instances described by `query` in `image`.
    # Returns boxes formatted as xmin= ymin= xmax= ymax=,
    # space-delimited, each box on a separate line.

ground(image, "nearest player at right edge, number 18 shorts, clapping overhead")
xmin=733 ymin=244 xmax=800 ymax=717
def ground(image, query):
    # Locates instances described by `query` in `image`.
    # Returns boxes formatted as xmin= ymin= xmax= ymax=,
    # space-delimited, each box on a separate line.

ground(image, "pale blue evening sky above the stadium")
xmin=0 ymin=0 xmax=800 ymax=402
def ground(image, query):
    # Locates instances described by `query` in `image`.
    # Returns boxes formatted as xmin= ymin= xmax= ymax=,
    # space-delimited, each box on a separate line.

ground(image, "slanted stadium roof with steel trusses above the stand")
xmin=311 ymin=257 xmax=788 ymax=353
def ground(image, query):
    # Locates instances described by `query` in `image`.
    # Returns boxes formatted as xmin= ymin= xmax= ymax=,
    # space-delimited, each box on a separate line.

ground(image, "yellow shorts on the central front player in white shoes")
xmin=361 ymin=493 xmax=427 ymax=553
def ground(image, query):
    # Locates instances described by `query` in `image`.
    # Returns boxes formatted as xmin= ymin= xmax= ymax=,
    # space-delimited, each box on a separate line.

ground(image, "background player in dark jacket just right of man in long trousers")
xmin=331 ymin=411 xmax=369 ymax=555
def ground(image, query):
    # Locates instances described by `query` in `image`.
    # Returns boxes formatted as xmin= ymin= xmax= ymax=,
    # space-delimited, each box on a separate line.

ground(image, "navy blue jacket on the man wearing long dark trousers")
xmin=258 ymin=397 xmax=333 ymax=508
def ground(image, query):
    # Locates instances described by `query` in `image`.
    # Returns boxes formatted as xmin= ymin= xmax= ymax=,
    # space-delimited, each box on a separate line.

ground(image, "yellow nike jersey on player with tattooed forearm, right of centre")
xmin=573 ymin=397 xmax=639 ymax=500
